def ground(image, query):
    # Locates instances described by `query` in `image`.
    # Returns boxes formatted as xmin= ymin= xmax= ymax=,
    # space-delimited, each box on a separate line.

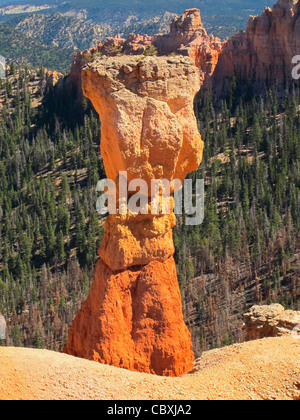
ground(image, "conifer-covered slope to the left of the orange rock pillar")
xmin=0 ymin=67 xmax=104 ymax=350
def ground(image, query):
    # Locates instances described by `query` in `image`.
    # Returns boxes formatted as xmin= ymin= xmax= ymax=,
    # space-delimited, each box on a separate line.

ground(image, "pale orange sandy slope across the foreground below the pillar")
xmin=0 ymin=336 xmax=300 ymax=400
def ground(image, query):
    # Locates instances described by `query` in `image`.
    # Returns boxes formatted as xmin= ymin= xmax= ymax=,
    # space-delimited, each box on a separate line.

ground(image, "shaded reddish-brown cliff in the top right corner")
xmin=214 ymin=0 xmax=300 ymax=92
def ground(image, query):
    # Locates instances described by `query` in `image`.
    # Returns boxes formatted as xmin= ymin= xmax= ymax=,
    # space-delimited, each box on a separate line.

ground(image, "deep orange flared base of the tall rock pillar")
xmin=64 ymin=258 xmax=194 ymax=376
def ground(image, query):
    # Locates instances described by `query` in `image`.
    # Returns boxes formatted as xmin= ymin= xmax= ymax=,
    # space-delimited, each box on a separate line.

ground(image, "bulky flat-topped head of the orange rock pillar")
xmin=82 ymin=56 xmax=203 ymax=184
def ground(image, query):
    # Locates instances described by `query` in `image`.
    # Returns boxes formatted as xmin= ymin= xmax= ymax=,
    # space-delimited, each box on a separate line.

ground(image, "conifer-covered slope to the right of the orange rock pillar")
xmin=174 ymin=85 xmax=300 ymax=352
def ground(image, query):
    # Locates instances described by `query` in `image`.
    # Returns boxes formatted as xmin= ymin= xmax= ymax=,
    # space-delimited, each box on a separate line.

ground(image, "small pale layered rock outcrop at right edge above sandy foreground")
xmin=244 ymin=304 xmax=300 ymax=341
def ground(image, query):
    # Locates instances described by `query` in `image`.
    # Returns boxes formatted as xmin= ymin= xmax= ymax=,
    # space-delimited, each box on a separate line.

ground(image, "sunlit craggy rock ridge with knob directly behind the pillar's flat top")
xmin=69 ymin=8 xmax=222 ymax=94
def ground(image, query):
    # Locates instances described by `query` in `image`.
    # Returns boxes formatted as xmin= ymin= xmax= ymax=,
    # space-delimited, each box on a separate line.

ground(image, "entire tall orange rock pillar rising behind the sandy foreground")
xmin=65 ymin=56 xmax=203 ymax=376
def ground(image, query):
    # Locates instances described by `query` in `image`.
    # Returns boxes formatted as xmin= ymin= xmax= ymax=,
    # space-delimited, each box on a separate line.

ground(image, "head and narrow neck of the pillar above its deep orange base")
xmin=82 ymin=56 xmax=203 ymax=270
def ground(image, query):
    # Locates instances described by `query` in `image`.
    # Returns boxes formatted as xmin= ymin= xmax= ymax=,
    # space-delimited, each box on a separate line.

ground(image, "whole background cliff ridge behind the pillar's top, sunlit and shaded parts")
xmin=65 ymin=0 xmax=300 ymax=106
